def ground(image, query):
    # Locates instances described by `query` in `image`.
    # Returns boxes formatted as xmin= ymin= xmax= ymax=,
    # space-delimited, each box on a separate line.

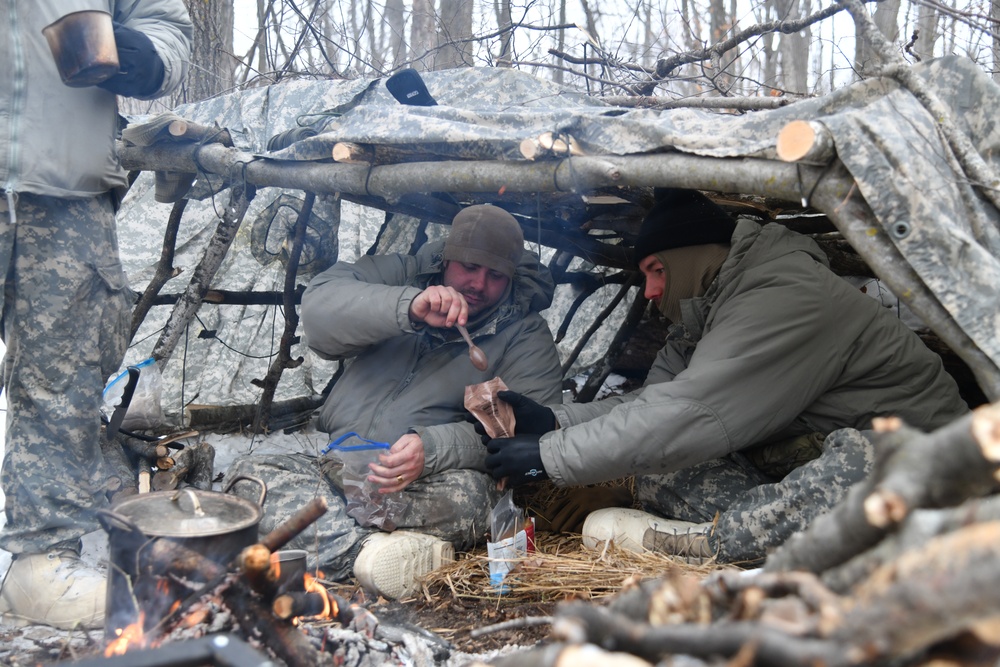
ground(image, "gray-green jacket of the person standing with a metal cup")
xmin=0 ymin=0 xmax=192 ymax=197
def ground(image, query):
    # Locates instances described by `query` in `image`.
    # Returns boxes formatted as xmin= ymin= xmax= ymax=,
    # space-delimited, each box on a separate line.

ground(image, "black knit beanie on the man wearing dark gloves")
xmin=634 ymin=188 xmax=736 ymax=264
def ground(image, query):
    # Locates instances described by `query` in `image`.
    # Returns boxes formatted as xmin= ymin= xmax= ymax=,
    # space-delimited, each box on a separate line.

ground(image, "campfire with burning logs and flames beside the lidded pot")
xmin=92 ymin=499 xmax=386 ymax=665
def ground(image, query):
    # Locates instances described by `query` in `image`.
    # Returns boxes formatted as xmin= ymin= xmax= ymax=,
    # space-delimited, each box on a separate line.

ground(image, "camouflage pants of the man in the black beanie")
xmin=636 ymin=429 xmax=874 ymax=564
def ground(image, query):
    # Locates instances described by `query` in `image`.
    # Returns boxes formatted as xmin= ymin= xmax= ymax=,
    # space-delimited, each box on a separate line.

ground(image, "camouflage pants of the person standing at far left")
xmin=0 ymin=194 xmax=131 ymax=554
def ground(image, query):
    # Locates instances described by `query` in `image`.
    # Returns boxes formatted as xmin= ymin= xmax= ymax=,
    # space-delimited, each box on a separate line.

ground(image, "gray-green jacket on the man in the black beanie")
xmin=541 ymin=220 xmax=968 ymax=485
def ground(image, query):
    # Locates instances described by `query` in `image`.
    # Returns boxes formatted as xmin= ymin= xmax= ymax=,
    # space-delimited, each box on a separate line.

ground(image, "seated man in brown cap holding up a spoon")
xmin=227 ymin=205 xmax=562 ymax=598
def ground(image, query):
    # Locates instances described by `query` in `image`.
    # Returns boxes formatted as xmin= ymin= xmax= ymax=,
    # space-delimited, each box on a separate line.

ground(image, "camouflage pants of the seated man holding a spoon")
xmin=226 ymin=454 xmax=500 ymax=581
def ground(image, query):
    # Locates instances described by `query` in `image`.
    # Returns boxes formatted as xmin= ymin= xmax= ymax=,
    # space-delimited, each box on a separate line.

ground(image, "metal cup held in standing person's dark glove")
xmin=42 ymin=10 xmax=119 ymax=88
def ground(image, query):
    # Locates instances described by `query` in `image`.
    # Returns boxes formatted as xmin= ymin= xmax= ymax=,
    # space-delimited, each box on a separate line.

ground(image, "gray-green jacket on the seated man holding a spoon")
xmin=302 ymin=241 xmax=562 ymax=475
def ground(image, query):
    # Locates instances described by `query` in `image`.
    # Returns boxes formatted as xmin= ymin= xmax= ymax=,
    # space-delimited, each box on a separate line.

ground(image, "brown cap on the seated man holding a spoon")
xmin=442 ymin=204 xmax=524 ymax=278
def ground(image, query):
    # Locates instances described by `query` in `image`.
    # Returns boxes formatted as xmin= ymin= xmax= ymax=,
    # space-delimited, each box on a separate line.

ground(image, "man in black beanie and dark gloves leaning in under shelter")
xmin=486 ymin=190 xmax=968 ymax=562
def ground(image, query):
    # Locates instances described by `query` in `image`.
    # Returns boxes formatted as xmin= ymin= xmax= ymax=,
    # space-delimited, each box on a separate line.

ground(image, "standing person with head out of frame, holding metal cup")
xmin=0 ymin=0 xmax=192 ymax=628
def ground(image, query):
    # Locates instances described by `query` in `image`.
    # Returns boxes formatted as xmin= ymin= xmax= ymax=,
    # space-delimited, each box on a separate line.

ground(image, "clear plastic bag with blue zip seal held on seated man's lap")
xmin=322 ymin=431 xmax=409 ymax=530
